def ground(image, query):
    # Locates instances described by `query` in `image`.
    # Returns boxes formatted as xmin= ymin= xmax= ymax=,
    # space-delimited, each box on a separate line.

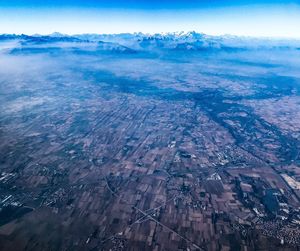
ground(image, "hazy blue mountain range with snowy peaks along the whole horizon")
xmin=0 ymin=31 xmax=300 ymax=53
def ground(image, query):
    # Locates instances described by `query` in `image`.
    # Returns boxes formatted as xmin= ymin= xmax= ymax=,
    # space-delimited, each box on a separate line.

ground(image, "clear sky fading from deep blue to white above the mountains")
xmin=0 ymin=0 xmax=300 ymax=38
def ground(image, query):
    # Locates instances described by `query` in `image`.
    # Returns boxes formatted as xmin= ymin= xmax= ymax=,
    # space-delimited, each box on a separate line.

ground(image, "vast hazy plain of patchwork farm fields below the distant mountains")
xmin=0 ymin=33 xmax=300 ymax=251
